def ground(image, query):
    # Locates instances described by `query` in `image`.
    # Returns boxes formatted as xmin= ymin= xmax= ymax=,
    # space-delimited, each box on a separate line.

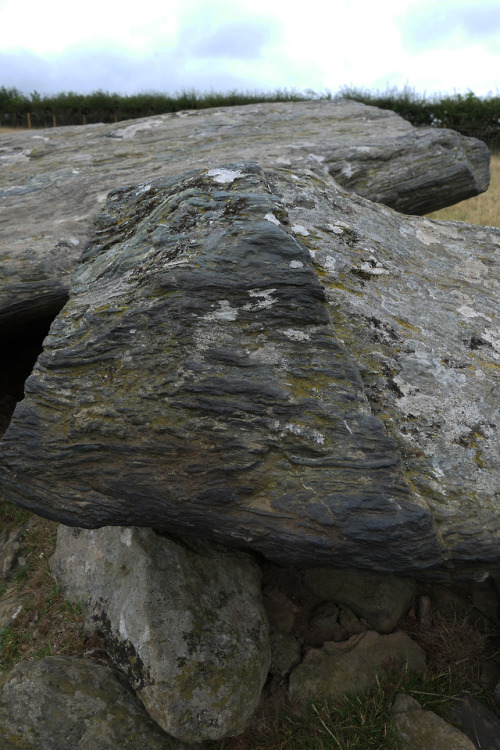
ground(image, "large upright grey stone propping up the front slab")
xmin=53 ymin=526 xmax=270 ymax=742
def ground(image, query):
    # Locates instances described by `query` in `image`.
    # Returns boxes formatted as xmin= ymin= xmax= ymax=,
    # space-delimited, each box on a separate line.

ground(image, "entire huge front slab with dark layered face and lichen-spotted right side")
xmin=0 ymin=163 xmax=500 ymax=577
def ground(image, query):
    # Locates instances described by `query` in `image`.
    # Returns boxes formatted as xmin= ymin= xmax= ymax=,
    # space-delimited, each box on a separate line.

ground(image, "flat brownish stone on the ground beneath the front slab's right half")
xmin=289 ymin=630 xmax=425 ymax=704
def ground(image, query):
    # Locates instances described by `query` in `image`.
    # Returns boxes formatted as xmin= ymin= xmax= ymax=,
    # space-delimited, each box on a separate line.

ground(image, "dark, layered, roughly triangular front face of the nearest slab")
xmin=0 ymin=164 xmax=440 ymax=568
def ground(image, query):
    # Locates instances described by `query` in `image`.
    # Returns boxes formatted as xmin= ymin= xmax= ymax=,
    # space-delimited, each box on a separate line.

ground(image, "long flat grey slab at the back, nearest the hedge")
xmin=0 ymin=101 xmax=489 ymax=337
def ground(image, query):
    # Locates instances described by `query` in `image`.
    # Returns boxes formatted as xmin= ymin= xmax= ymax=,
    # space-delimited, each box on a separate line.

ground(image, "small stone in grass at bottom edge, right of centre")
xmin=393 ymin=694 xmax=476 ymax=750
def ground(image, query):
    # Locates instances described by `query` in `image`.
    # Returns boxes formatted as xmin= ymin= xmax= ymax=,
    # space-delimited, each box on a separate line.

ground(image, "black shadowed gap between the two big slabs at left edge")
xmin=0 ymin=317 xmax=53 ymax=437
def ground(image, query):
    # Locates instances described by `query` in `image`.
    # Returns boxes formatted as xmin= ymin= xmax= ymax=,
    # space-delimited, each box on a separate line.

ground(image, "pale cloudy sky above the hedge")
xmin=0 ymin=0 xmax=500 ymax=96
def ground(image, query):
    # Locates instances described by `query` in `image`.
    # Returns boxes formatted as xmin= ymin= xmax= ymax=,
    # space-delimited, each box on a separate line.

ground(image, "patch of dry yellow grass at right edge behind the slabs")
xmin=429 ymin=154 xmax=500 ymax=227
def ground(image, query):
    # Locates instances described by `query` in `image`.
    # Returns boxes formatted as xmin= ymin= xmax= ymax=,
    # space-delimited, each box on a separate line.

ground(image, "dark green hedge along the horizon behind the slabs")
xmin=0 ymin=86 xmax=500 ymax=149
